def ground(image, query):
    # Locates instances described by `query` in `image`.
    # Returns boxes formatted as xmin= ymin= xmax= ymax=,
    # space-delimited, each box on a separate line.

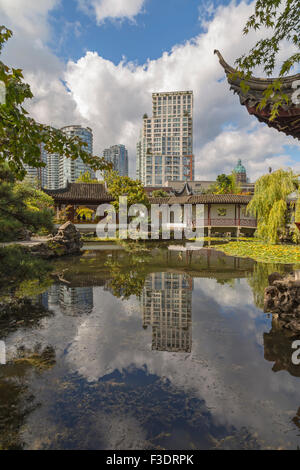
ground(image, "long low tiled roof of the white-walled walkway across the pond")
xmin=149 ymin=194 xmax=252 ymax=204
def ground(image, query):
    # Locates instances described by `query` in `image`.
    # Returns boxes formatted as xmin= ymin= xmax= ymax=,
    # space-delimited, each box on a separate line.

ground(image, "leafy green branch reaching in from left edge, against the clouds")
xmin=0 ymin=26 xmax=107 ymax=179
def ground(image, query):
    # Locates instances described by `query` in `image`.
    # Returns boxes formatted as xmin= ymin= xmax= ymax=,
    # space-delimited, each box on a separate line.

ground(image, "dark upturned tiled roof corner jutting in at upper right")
xmin=215 ymin=50 xmax=300 ymax=140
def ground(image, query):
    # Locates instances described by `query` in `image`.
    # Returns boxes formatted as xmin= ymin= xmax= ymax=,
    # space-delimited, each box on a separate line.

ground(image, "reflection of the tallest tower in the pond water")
xmin=141 ymin=272 xmax=193 ymax=352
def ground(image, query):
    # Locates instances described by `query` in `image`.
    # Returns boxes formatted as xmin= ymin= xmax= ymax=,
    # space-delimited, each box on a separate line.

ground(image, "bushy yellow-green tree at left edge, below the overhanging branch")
xmin=0 ymin=164 xmax=53 ymax=241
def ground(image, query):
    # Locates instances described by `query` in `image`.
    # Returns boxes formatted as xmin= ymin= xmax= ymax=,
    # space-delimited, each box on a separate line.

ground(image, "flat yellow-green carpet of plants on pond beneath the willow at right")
xmin=213 ymin=240 xmax=300 ymax=264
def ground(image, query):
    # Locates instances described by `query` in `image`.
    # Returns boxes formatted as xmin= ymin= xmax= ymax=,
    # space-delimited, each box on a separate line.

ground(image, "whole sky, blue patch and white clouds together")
xmin=0 ymin=0 xmax=300 ymax=181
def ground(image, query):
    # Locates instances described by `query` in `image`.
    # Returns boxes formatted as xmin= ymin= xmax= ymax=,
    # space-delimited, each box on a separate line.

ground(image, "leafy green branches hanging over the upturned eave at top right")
xmin=236 ymin=0 xmax=300 ymax=120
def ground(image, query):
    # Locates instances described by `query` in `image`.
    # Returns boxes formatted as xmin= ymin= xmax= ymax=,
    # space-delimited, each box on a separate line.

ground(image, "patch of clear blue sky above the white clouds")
xmin=49 ymin=0 xmax=228 ymax=64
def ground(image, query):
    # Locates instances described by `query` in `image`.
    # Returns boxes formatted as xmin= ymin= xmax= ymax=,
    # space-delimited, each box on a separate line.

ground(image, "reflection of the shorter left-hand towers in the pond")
xmin=48 ymin=284 xmax=94 ymax=315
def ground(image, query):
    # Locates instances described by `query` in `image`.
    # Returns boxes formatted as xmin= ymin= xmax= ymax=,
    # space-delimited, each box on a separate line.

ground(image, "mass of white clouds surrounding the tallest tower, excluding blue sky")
xmin=0 ymin=0 xmax=299 ymax=180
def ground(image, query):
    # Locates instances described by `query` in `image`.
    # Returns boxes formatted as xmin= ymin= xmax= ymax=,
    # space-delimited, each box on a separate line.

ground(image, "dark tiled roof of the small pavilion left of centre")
xmin=44 ymin=183 xmax=113 ymax=203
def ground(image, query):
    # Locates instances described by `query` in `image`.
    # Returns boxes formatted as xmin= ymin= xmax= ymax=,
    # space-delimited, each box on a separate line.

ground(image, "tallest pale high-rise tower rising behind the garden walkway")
xmin=137 ymin=91 xmax=194 ymax=186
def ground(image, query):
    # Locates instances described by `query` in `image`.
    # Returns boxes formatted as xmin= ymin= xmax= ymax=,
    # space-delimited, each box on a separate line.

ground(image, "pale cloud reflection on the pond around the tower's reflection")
xmin=63 ymin=279 xmax=300 ymax=443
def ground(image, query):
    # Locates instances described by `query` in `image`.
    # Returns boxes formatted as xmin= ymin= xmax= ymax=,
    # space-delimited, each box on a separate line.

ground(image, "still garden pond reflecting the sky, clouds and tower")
xmin=0 ymin=245 xmax=300 ymax=450
